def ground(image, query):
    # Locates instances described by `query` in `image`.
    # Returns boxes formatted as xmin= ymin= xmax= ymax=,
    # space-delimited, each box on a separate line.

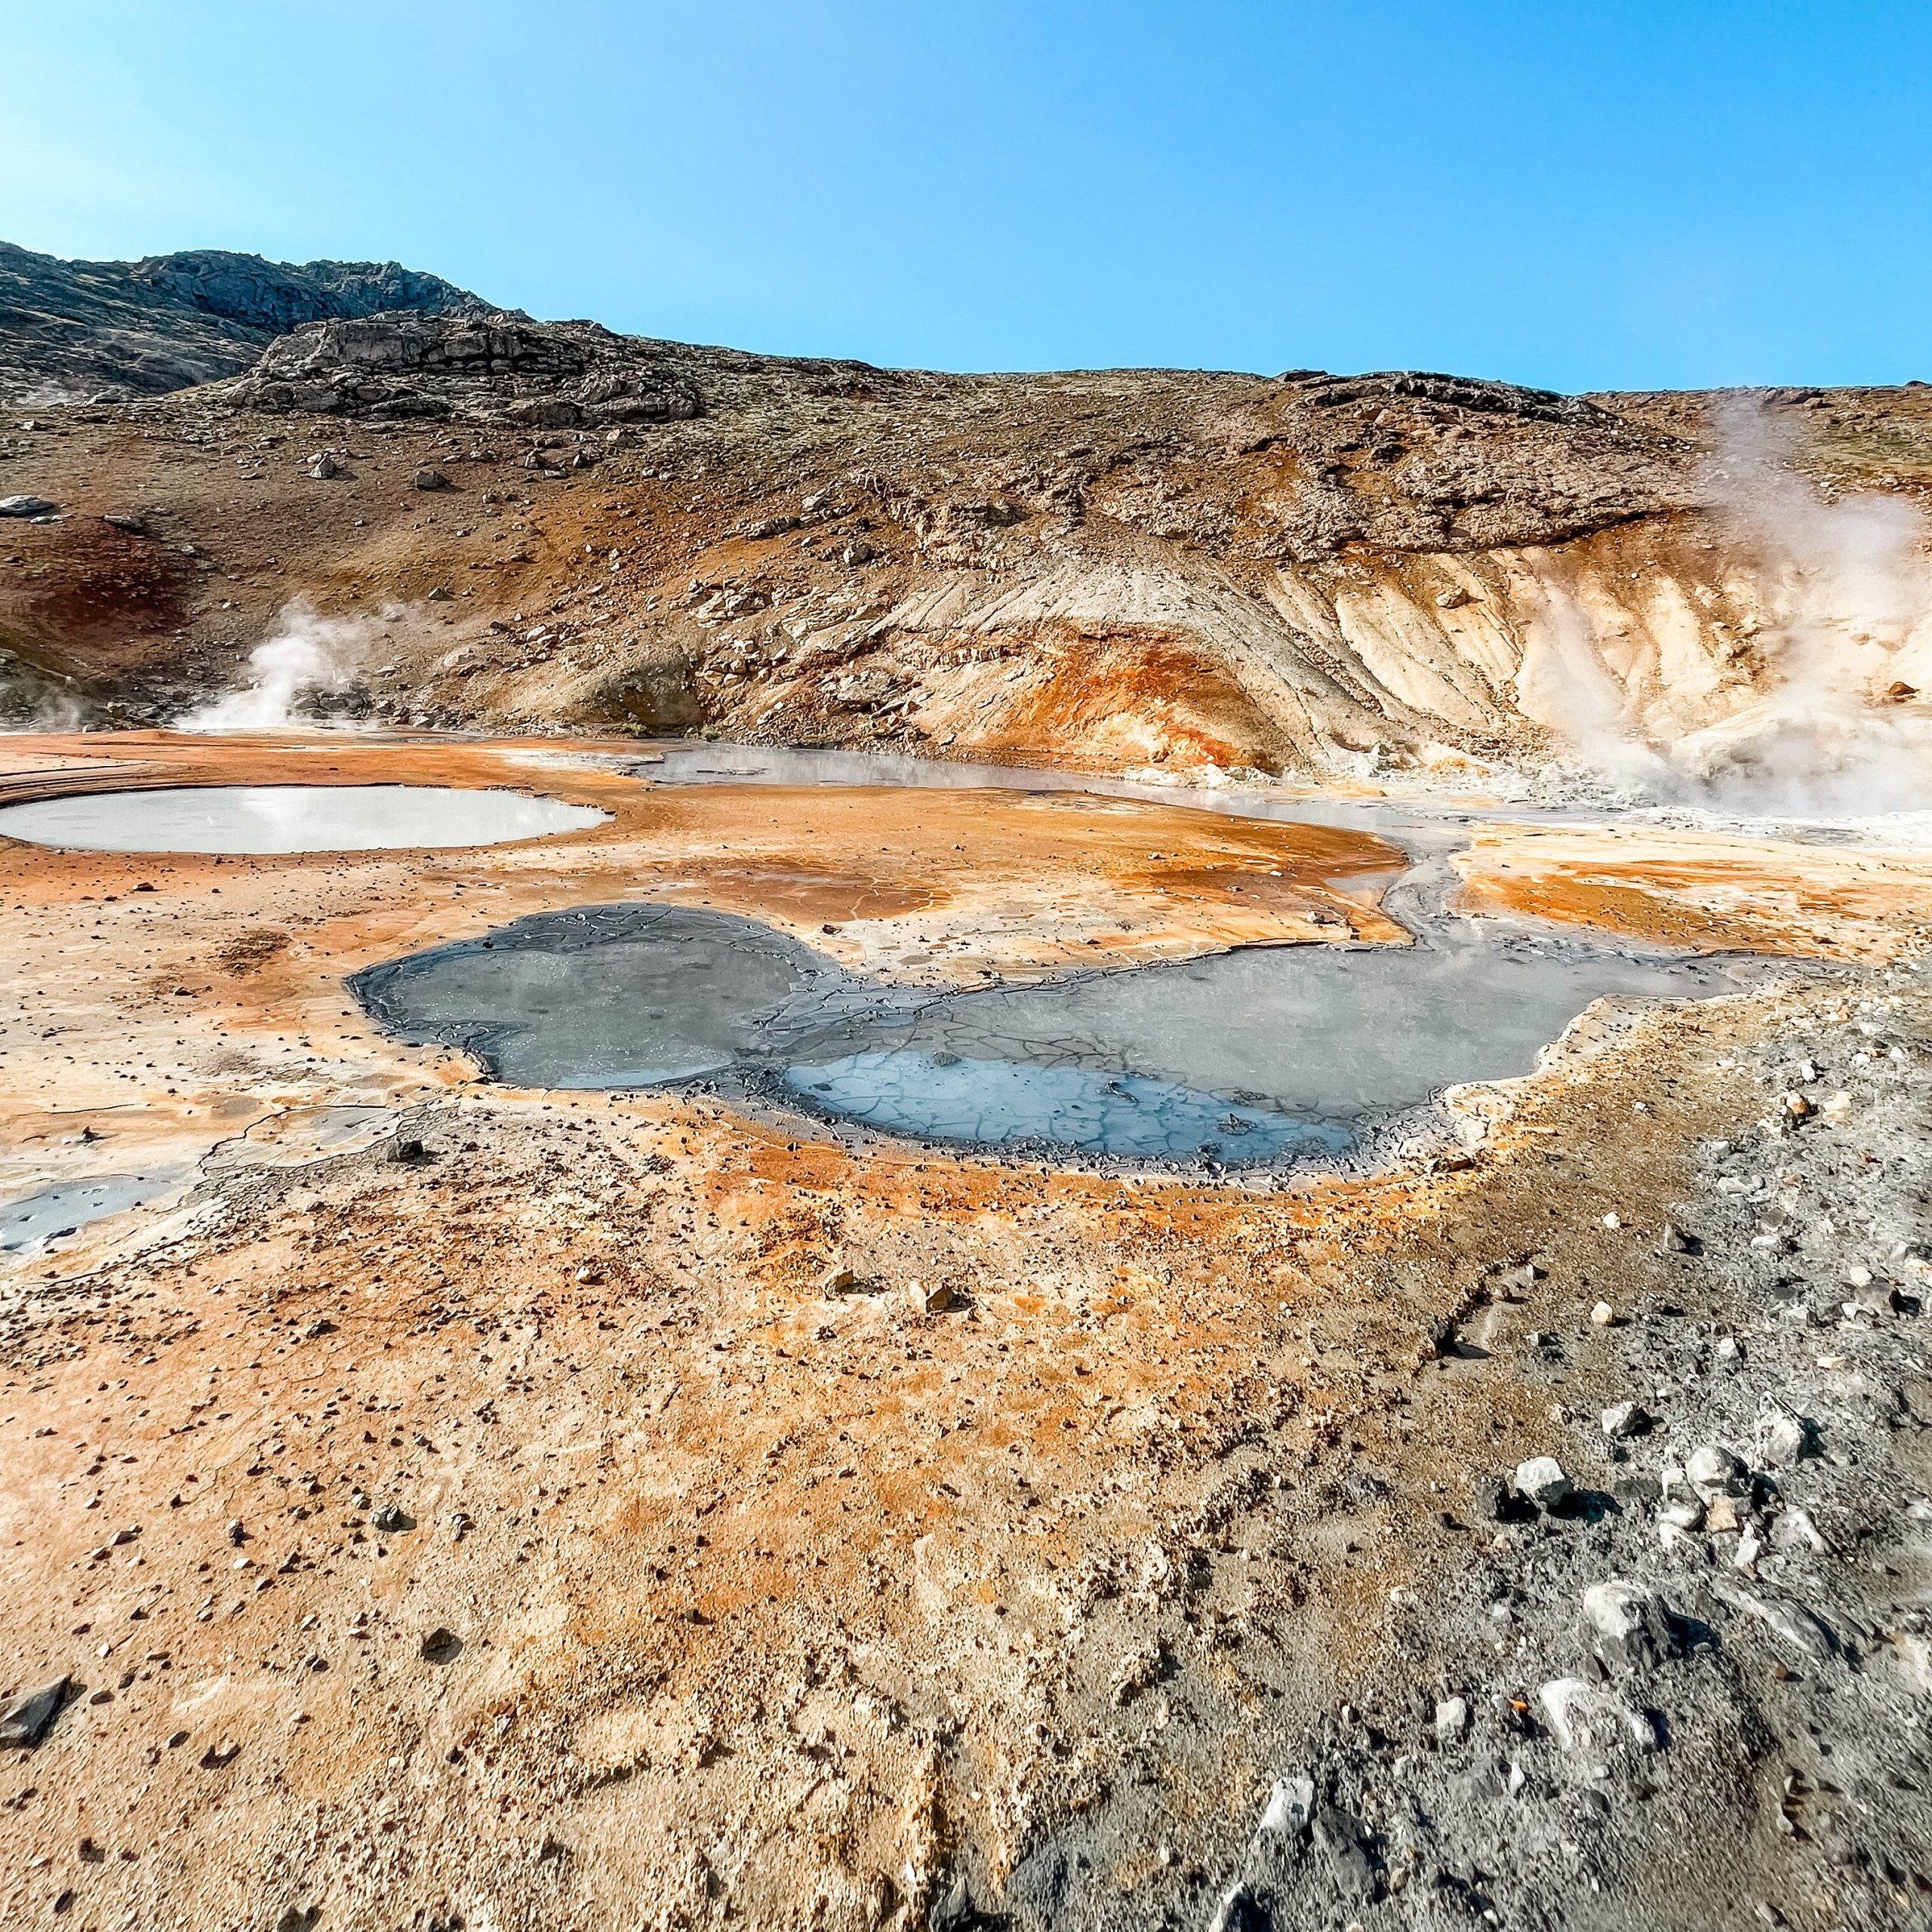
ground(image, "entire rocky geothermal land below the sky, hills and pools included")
xmin=0 ymin=237 xmax=1932 ymax=1932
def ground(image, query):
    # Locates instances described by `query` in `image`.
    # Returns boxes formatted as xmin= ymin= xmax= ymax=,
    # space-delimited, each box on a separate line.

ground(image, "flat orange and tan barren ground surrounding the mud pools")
xmin=0 ymin=736 xmax=1932 ymax=1928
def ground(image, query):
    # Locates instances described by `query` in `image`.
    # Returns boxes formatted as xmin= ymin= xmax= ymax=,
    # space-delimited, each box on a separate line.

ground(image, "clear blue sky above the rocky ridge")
xmin=0 ymin=0 xmax=1932 ymax=390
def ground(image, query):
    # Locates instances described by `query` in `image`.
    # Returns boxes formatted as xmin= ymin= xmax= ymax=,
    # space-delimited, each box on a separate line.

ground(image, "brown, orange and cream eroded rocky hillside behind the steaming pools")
xmin=0 ymin=315 xmax=1932 ymax=792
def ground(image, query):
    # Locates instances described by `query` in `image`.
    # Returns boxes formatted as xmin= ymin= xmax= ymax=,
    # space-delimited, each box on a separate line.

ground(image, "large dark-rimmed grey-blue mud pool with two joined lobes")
xmin=349 ymin=904 xmax=1739 ymax=1167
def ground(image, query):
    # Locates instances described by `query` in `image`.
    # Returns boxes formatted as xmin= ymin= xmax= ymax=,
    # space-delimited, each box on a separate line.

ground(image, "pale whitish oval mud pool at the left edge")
xmin=0 ymin=784 xmax=605 ymax=854
